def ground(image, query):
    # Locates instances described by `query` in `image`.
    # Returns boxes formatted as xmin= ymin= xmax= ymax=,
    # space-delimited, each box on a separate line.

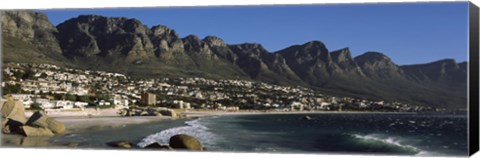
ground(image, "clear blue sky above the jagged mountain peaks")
xmin=40 ymin=2 xmax=468 ymax=65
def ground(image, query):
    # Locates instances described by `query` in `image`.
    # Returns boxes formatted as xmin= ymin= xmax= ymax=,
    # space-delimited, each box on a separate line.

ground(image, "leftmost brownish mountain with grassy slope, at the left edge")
xmin=0 ymin=11 xmax=68 ymax=65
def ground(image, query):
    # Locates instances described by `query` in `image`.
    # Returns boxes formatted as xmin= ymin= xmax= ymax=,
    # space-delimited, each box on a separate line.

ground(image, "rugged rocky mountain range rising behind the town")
xmin=1 ymin=10 xmax=467 ymax=110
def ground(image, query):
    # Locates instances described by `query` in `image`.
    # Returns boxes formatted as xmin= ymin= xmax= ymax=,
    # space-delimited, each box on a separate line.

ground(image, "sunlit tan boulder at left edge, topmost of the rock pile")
xmin=1 ymin=96 xmax=27 ymax=124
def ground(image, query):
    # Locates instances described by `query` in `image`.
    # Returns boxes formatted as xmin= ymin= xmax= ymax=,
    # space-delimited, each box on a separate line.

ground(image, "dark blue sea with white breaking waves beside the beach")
xmin=52 ymin=113 xmax=468 ymax=156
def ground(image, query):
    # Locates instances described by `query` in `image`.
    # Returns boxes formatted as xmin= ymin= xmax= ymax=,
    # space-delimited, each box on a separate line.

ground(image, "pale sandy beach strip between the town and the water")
xmin=20 ymin=109 xmax=417 ymax=134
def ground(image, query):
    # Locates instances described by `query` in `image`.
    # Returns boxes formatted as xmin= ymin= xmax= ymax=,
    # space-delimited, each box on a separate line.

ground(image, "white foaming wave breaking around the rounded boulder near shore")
xmin=137 ymin=118 xmax=216 ymax=148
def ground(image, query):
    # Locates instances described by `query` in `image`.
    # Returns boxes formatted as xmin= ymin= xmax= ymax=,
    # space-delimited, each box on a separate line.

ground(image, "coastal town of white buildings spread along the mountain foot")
xmin=2 ymin=63 xmax=436 ymax=112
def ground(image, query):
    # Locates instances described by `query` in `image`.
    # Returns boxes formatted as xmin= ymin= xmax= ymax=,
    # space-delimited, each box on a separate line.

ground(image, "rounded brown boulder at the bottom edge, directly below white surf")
xmin=169 ymin=134 xmax=203 ymax=151
